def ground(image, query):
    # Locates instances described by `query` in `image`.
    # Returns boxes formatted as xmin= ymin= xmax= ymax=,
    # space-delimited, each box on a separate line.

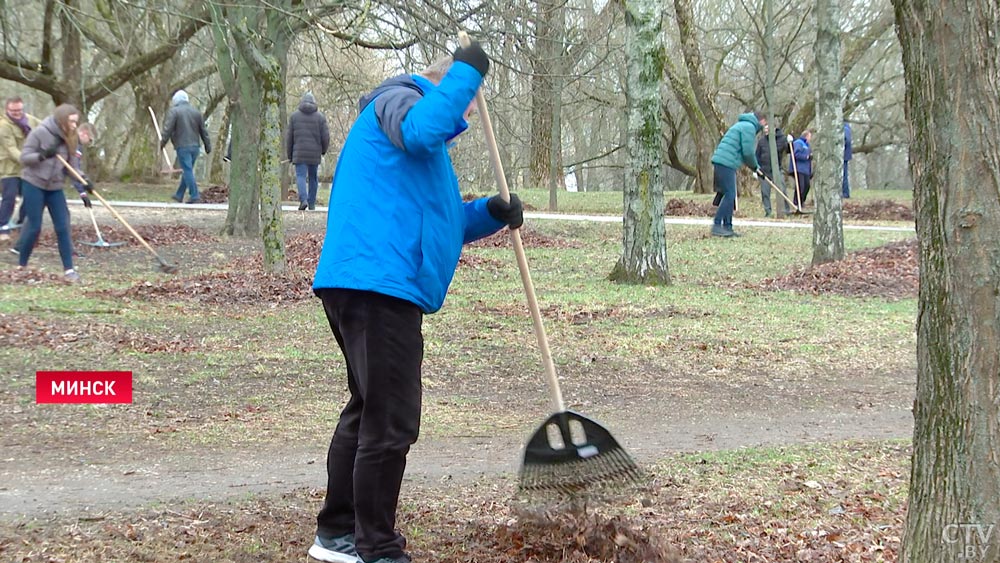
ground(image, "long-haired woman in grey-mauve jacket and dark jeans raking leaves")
xmin=15 ymin=104 xmax=90 ymax=282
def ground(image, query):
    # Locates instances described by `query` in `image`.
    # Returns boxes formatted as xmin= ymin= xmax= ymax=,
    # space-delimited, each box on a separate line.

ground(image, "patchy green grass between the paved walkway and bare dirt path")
xmin=0 ymin=214 xmax=916 ymax=452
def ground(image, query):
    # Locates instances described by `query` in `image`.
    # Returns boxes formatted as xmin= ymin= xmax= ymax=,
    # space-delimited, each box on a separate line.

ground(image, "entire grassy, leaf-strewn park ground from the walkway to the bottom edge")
xmin=0 ymin=205 xmax=915 ymax=563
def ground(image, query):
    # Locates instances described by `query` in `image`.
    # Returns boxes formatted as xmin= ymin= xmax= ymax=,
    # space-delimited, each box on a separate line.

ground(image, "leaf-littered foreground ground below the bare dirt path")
xmin=0 ymin=443 xmax=908 ymax=563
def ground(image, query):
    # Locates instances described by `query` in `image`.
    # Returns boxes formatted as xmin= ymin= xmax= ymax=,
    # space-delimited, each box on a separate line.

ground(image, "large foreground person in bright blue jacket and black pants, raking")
xmin=309 ymin=43 xmax=523 ymax=563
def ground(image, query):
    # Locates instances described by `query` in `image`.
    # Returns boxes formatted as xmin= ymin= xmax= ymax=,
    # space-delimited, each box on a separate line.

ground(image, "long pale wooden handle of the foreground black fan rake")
xmin=458 ymin=31 xmax=566 ymax=412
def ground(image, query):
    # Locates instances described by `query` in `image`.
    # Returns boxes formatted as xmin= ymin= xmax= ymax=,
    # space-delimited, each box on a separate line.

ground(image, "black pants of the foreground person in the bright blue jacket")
xmin=316 ymin=289 xmax=424 ymax=561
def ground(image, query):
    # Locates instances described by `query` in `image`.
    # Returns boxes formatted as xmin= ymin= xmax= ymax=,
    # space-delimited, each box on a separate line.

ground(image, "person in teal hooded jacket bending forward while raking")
xmin=712 ymin=112 xmax=767 ymax=237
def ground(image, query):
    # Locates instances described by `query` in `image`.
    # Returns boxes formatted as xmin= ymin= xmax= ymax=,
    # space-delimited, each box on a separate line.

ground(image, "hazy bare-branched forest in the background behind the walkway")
xmin=0 ymin=0 xmax=909 ymax=200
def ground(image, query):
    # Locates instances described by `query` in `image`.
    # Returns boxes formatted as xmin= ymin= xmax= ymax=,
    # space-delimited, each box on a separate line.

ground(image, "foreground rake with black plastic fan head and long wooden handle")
xmin=458 ymin=31 xmax=640 ymax=494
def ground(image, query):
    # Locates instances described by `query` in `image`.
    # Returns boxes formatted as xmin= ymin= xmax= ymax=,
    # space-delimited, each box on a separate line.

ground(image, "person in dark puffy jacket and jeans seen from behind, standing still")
xmin=285 ymin=92 xmax=330 ymax=211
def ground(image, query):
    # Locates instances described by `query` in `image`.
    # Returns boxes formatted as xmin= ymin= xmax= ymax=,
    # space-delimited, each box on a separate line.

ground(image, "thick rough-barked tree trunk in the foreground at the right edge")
xmin=893 ymin=0 xmax=1000 ymax=563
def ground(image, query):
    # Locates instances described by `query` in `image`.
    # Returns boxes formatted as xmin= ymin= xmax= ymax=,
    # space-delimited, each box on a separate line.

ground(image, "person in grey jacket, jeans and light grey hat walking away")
xmin=160 ymin=90 xmax=212 ymax=203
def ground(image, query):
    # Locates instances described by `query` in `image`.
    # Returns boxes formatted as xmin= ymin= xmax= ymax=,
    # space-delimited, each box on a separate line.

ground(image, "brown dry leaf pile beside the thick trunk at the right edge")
xmin=759 ymin=239 xmax=920 ymax=300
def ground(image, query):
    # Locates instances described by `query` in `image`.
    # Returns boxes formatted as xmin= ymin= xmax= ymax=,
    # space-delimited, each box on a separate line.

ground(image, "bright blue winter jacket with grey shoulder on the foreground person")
xmin=313 ymin=62 xmax=504 ymax=313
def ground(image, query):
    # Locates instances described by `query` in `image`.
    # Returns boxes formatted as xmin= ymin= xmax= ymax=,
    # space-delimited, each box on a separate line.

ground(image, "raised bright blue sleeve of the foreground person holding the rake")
xmin=400 ymin=62 xmax=483 ymax=155
